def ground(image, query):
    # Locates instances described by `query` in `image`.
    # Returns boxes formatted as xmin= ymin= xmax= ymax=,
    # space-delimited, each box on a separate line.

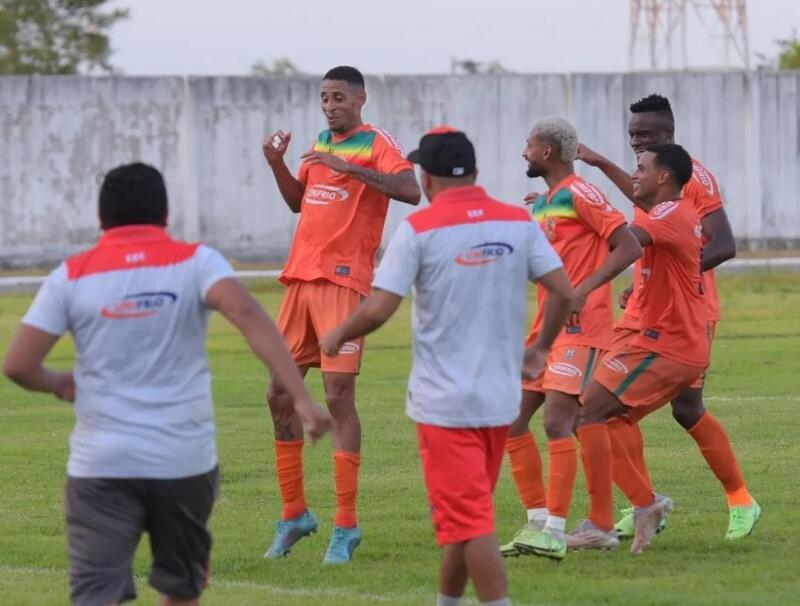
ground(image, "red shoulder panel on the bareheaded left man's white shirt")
xmin=66 ymin=225 xmax=200 ymax=280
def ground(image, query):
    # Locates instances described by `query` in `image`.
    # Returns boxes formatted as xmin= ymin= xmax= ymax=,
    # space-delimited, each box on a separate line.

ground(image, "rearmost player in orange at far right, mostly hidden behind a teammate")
xmin=578 ymin=95 xmax=761 ymax=539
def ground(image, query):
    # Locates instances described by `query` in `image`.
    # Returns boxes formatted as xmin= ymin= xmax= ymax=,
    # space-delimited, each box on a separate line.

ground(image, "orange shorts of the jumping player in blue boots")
xmin=276 ymin=280 xmax=364 ymax=374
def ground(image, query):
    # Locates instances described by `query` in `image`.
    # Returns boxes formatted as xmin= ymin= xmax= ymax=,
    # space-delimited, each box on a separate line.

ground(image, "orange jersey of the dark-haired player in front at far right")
xmin=633 ymin=199 xmax=709 ymax=367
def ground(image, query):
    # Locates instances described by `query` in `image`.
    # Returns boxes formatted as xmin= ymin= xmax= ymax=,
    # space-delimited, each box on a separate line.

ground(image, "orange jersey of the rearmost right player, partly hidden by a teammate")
xmin=619 ymin=159 xmax=722 ymax=325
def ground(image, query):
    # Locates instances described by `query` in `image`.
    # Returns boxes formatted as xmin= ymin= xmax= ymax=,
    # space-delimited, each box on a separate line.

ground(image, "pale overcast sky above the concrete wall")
xmin=110 ymin=0 xmax=800 ymax=75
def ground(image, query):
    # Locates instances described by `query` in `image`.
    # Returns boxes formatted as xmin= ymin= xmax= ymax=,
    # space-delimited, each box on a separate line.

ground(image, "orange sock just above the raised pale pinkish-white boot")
xmin=607 ymin=417 xmax=654 ymax=507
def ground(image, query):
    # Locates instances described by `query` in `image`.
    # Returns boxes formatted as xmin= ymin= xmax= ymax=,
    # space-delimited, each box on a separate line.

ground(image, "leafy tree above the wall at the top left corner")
xmin=0 ymin=0 xmax=128 ymax=74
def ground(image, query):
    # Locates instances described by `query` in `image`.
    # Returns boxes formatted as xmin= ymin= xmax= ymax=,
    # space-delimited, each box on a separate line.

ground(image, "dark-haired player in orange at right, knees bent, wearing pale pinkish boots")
xmin=568 ymin=143 xmax=709 ymax=554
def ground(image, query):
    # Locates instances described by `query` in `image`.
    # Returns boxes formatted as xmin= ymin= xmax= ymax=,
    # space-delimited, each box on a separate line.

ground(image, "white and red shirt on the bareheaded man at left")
xmin=23 ymin=225 xmax=234 ymax=479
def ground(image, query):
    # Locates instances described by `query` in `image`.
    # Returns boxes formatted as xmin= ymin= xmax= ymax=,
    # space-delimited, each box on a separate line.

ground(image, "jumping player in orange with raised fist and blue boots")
xmin=263 ymin=66 xmax=421 ymax=564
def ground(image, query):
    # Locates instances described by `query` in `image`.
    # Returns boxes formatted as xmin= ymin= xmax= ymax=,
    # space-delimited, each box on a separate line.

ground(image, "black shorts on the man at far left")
xmin=64 ymin=468 xmax=219 ymax=606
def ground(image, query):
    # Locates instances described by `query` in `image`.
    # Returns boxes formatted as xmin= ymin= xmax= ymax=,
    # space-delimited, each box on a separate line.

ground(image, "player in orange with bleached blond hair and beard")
xmin=501 ymin=118 xmax=641 ymax=559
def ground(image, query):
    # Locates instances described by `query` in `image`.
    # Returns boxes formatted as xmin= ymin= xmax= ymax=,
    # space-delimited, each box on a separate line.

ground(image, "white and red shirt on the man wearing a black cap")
xmin=372 ymin=186 xmax=562 ymax=427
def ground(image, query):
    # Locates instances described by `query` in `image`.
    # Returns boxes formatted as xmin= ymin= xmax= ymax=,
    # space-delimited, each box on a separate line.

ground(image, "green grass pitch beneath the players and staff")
xmin=0 ymin=273 xmax=800 ymax=606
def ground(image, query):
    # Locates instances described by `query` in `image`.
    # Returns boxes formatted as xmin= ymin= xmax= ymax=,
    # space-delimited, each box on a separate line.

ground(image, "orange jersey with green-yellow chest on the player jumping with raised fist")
xmin=280 ymin=124 xmax=414 ymax=295
